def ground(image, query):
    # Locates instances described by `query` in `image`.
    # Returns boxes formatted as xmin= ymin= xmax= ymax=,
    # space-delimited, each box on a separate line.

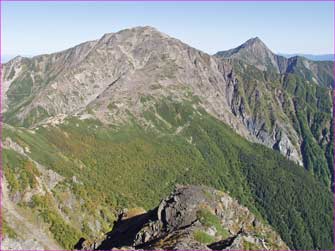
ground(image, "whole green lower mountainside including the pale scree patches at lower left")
xmin=3 ymin=99 xmax=333 ymax=250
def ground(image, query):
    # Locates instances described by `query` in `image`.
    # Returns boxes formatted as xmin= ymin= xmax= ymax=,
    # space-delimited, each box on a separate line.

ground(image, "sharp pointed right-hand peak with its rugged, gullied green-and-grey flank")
xmin=214 ymin=38 xmax=334 ymax=187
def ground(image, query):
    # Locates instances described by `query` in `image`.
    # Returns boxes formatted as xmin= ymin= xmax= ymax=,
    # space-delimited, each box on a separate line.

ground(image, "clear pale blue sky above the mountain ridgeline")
xmin=2 ymin=2 xmax=334 ymax=60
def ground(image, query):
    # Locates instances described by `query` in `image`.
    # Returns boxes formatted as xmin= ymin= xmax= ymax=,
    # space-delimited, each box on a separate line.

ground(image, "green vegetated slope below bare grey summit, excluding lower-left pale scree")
xmin=4 ymin=100 xmax=333 ymax=249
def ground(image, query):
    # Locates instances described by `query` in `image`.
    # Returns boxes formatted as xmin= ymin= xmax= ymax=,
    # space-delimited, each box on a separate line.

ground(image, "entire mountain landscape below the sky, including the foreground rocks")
xmin=1 ymin=26 xmax=334 ymax=250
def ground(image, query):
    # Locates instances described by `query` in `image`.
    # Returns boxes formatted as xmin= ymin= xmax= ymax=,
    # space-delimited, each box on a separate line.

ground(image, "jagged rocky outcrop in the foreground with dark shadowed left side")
xmin=76 ymin=186 xmax=288 ymax=250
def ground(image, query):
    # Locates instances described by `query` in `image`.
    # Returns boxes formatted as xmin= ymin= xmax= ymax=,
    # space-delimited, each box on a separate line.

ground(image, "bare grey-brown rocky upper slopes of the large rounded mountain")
xmin=2 ymin=27 xmax=332 ymax=183
